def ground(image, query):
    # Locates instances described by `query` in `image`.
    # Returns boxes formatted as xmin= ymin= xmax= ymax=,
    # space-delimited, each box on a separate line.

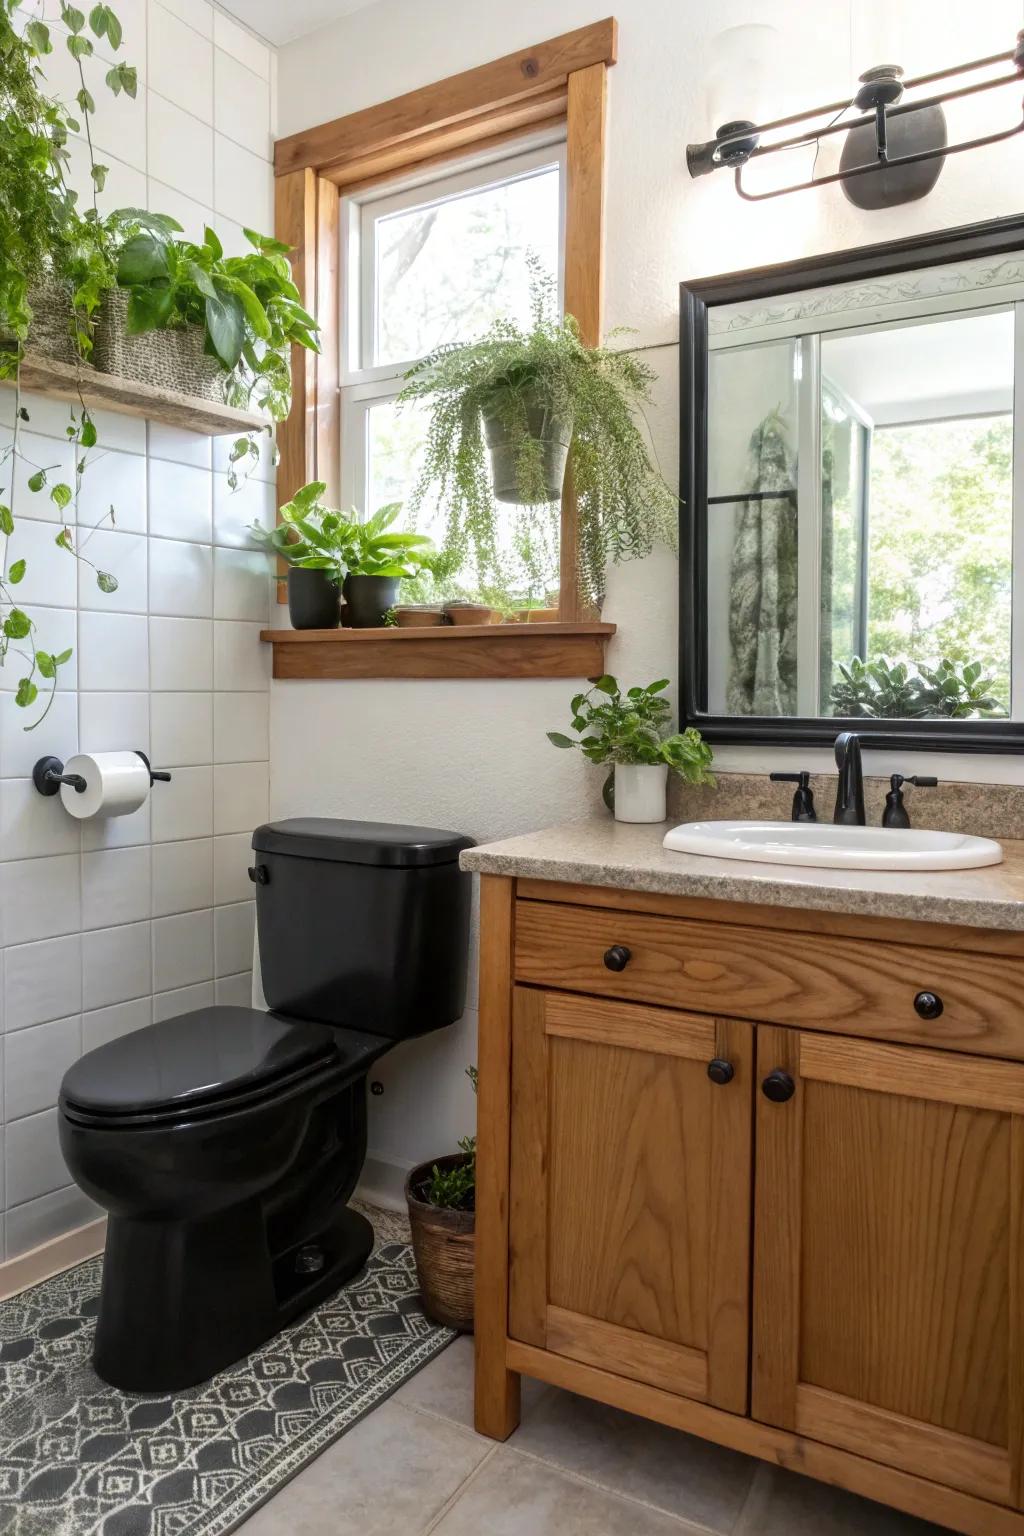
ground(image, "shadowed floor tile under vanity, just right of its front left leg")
xmin=508 ymin=1390 xmax=757 ymax=1531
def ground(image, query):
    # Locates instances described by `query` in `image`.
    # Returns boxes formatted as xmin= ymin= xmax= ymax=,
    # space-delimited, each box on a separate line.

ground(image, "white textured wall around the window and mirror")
xmin=270 ymin=0 xmax=1024 ymax=1185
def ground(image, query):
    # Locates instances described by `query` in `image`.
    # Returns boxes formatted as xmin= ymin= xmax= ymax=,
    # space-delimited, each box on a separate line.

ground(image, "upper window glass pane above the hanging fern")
xmin=373 ymin=164 xmax=559 ymax=366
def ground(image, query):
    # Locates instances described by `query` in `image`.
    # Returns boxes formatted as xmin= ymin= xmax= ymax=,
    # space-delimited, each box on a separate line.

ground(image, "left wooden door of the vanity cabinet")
xmin=508 ymin=988 xmax=754 ymax=1413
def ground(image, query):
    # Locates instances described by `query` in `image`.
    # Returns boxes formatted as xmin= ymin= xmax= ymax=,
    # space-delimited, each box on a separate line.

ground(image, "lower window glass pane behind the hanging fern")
xmin=367 ymin=401 xmax=560 ymax=611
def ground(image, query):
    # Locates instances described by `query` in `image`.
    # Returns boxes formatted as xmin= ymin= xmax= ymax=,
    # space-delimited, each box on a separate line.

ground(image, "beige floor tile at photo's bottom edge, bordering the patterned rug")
xmin=234 ymin=1401 xmax=490 ymax=1536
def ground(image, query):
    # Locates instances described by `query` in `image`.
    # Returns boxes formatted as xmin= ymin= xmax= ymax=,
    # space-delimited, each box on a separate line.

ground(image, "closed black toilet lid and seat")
xmin=61 ymin=1006 xmax=348 ymax=1118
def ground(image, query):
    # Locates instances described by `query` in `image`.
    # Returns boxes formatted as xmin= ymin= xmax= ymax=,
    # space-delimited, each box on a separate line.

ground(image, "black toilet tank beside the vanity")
xmin=249 ymin=817 xmax=473 ymax=1040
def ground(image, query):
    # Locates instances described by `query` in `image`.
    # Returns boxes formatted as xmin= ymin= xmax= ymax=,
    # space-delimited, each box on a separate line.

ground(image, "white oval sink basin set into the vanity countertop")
xmin=665 ymin=822 xmax=1003 ymax=869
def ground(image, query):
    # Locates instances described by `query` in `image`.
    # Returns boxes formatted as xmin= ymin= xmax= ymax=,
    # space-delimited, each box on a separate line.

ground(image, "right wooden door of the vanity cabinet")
xmin=751 ymin=1026 xmax=1024 ymax=1505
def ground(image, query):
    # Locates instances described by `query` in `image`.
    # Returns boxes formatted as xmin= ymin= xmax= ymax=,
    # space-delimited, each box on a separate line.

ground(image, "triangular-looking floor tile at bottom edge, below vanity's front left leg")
xmin=433 ymin=1445 xmax=706 ymax=1536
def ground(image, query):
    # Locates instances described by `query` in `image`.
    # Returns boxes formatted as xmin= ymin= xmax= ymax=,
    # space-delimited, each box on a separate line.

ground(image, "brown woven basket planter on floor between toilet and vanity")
xmin=405 ymin=1152 xmax=476 ymax=1333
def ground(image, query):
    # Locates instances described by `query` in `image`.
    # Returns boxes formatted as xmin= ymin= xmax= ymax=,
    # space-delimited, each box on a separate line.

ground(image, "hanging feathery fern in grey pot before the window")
xmin=399 ymin=275 xmax=677 ymax=604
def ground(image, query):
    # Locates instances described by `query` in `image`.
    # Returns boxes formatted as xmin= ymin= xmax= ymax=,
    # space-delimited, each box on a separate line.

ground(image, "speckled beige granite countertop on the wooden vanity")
xmin=461 ymin=817 xmax=1024 ymax=931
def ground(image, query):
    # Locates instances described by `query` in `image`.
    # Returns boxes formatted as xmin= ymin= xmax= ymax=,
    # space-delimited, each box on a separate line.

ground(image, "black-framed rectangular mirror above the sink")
xmin=680 ymin=217 xmax=1024 ymax=753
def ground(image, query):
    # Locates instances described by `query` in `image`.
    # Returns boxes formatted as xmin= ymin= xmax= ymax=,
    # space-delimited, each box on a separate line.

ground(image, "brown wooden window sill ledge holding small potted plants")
xmin=259 ymin=621 xmax=616 ymax=680
